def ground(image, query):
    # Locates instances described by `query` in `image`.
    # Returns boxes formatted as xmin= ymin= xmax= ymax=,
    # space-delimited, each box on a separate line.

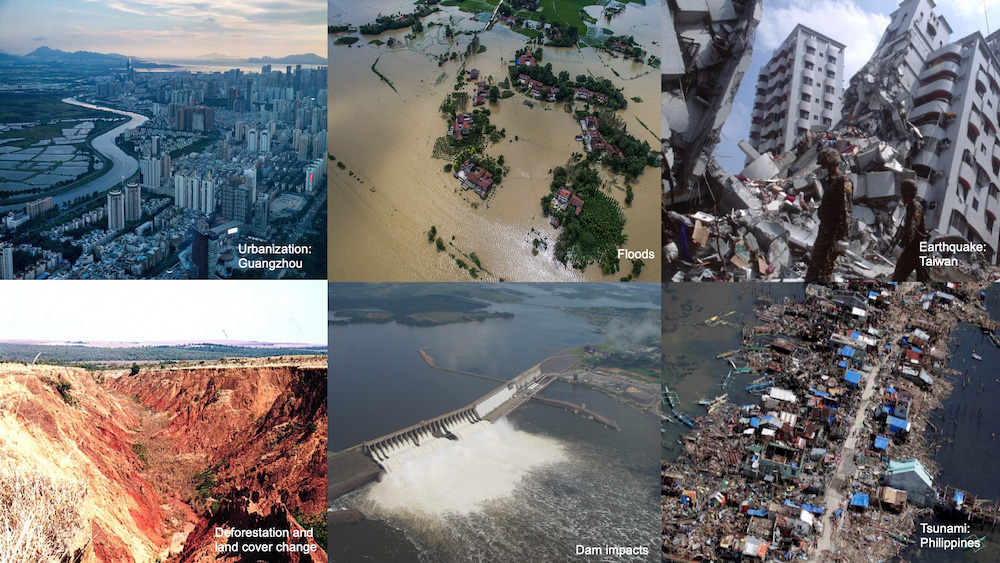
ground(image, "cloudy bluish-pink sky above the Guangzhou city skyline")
xmin=0 ymin=0 xmax=326 ymax=60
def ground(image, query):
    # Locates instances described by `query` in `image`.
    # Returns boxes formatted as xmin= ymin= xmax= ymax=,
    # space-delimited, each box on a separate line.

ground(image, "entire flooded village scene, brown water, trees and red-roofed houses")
xmin=328 ymin=0 xmax=660 ymax=281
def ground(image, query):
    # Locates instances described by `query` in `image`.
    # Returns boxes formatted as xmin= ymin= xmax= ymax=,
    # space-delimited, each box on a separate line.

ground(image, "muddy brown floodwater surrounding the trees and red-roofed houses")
xmin=329 ymin=1 xmax=660 ymax=281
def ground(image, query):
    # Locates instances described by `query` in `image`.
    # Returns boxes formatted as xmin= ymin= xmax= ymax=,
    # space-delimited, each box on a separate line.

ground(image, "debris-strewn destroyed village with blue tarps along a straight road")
xmin=661 ymin=283 xmax=1000 ymax=562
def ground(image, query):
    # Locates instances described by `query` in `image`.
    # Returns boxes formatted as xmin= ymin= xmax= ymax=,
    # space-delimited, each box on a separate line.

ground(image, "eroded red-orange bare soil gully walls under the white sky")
xmin=0 ymin=357 xmax=327 ymax=563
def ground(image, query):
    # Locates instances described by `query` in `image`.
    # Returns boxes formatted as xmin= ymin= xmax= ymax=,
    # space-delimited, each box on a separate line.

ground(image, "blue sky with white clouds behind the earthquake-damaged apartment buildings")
xmin=715 ymin=0 xmax=1000 ymax=174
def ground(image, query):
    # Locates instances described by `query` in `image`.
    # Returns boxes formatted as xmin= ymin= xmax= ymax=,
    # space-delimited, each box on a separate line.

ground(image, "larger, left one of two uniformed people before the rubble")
xmin=806 ymin=148 xmax=854 ymax=282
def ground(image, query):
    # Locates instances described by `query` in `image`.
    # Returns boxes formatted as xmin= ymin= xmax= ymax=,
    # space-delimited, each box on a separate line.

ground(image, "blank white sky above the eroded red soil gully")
xmin=0 ymin=280 xmax=327 ymax=345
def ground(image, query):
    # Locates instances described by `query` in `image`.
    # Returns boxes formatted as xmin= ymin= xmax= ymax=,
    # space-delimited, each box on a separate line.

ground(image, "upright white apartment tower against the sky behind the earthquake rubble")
xmin=750 ymin=24 xmax=844 ymax=156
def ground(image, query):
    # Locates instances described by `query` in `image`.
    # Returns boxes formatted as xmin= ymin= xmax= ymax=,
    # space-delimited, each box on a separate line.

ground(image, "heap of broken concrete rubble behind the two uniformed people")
xmin=663 ymin=127 xmax=992 ymax=282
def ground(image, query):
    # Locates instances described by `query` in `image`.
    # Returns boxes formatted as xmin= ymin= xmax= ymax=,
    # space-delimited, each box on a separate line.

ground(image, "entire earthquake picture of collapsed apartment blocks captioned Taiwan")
xmin=661 ymin=0 xmax=1000 ymax=282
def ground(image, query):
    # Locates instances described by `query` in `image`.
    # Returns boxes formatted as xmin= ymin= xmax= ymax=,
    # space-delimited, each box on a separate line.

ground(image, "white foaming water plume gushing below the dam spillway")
xmin=364 ymin=419 xmax=567 ymax=517
